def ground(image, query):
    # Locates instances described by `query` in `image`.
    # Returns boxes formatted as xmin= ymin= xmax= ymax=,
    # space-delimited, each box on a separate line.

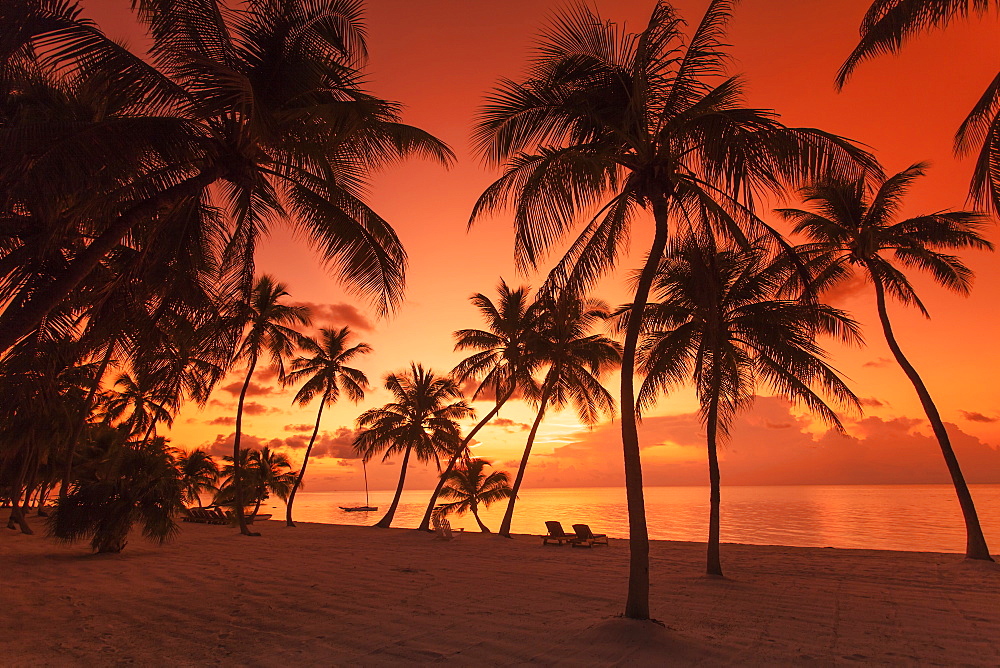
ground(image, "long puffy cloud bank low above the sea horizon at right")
xmin=526 ymin=397 xmax=1000 ymax=487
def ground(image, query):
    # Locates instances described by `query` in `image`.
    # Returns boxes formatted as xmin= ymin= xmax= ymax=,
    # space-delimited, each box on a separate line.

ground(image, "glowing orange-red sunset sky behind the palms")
xmin=83 ymin=0 xmax=1000 ymax=491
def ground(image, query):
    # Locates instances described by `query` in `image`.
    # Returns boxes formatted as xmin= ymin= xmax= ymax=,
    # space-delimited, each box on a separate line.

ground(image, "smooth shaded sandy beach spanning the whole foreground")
xmin=0 ymin=521 xmax=1000 ymax=666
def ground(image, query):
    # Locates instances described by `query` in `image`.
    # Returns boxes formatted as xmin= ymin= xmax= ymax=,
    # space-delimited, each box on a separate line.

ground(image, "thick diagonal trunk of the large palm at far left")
xmin=0 ymin=168 xmax=222 ymax=352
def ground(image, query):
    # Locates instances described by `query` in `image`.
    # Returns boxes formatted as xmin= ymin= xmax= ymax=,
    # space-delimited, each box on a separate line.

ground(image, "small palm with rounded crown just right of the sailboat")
xmin=354 ymin=363 xmax=474 ymax=528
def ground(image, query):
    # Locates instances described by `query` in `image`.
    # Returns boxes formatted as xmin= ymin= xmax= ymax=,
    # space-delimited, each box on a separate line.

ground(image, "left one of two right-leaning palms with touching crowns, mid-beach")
xmin=417 ymin=279 xmax=538 ymax=531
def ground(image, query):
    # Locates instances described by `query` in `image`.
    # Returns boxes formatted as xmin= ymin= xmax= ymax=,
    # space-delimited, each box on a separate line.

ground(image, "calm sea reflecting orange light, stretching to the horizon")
xmin=265 ymin=485 xmax=1000 ymax=554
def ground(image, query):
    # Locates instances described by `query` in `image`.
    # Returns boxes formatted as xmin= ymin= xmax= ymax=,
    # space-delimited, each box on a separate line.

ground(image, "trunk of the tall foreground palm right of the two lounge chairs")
xmin=620 ymin=193 xmax=668 ymax=619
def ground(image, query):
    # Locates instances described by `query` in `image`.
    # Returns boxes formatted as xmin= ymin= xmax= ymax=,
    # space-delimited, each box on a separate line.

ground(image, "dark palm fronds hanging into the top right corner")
xmin=837 ymin=0 xmax=1000 ymax=211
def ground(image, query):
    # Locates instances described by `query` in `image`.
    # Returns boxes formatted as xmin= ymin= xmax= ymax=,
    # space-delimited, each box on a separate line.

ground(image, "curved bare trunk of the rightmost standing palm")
xmin=873 ymin=277 xmax=993 ymax=561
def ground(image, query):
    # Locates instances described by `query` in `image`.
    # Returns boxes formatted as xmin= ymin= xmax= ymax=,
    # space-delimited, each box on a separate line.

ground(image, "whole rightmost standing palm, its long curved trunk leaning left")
xmin=777 ymin=163 xmax=993 ymax=561
